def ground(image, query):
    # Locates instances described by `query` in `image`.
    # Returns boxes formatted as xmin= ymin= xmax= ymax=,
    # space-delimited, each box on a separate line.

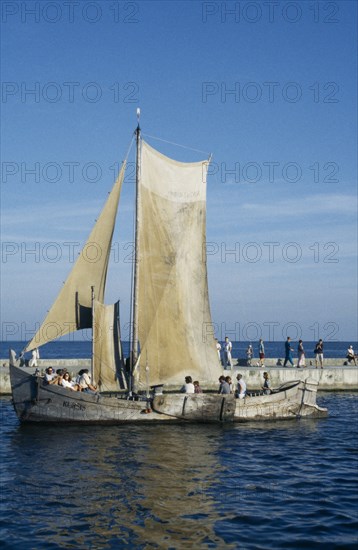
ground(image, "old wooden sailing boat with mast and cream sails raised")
xmin=10 ymin=111 xmax=325 ymax=423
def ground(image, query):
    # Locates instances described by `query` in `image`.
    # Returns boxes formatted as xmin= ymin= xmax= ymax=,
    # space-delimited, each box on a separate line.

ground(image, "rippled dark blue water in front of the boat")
xmin=0 ymin=392 xmax=358 ymax=550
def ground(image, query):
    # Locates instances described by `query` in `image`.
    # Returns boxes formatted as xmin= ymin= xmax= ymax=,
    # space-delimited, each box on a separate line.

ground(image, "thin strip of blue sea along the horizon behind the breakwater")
xmin=0 ymin=340 xmax=358 ymax=359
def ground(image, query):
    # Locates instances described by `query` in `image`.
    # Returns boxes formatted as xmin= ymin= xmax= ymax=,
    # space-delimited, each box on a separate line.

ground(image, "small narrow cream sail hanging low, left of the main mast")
xmin=93 ymin=300 xmax=127 ymax=391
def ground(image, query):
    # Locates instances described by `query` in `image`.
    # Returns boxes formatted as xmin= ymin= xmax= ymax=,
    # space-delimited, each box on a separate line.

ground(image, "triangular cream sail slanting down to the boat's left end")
xmin=24 ymin=163 xmax=125 ymax=351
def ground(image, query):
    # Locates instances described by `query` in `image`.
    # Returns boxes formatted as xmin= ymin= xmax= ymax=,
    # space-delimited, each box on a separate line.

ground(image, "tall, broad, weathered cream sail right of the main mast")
xmin=138 ymin=142 xmax=222 ymax=387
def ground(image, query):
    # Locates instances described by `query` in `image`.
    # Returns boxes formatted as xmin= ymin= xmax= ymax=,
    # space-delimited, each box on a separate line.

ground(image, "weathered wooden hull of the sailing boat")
xmin=10 ymin=365 xmax=327 ymax=424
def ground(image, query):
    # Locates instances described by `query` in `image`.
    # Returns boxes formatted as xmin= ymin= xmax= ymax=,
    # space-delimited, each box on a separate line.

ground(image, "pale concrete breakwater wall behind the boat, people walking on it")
xmin=0 ymin=359 xmax=358 ymax=395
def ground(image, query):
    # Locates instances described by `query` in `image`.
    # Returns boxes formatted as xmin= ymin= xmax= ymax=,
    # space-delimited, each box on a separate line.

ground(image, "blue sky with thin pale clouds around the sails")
xmin=1 ymin=0 xmax=357 ymax=341
